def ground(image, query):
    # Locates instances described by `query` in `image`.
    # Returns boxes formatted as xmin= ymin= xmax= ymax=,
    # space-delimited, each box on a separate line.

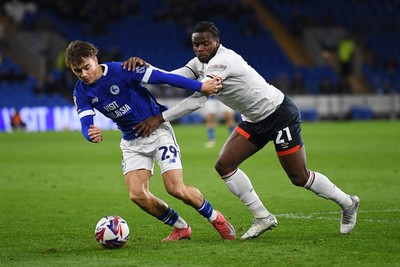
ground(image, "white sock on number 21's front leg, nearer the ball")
xmin=222 ymin=169 xmax=269 ymax=218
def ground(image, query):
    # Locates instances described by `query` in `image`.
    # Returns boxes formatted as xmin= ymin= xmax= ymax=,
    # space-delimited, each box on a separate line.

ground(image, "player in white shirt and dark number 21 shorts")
xmin=124 ymin=22 xmax=360 ymax=239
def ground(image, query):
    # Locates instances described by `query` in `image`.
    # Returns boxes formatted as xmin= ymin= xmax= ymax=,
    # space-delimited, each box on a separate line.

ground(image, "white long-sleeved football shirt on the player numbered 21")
xmin=162 ymin=45 xmax=284 ymax=122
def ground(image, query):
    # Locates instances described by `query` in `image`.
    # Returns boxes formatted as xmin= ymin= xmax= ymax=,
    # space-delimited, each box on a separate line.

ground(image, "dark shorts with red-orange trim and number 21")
xmin=235 ymin=96 xmax=303 ymax=156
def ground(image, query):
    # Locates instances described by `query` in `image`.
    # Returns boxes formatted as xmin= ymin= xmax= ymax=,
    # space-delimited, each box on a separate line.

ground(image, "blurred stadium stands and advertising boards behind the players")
xmin=0 ymin=0 xmax=400 ymax=132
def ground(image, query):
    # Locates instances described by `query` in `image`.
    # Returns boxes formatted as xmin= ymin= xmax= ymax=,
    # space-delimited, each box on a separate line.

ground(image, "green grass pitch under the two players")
xmin=0 ymin=121 xmax=400 ymax=266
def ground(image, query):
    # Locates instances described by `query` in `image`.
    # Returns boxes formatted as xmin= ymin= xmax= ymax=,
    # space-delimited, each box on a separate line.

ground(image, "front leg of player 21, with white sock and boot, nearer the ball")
xmin=215 ymin=131 xmax=277 ymax=239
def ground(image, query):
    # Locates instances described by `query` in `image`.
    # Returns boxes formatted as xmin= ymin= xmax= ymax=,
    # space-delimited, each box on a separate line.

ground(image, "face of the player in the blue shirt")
xmin=71 ymin=57 xmax=101 ymax=84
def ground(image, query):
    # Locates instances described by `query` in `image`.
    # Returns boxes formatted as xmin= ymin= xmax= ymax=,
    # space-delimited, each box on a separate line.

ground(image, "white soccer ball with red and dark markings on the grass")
xmin=94 ymin=215 xmax=129 ymax=248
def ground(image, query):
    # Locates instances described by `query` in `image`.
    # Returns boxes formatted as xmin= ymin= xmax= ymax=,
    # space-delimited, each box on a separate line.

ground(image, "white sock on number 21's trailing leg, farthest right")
xmin=304 ymin=170 xmax=353 ymax=208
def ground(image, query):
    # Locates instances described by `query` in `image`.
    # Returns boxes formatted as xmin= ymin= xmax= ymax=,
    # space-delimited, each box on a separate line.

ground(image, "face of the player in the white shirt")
xmin=192 ymin=32 xmax=219 ymax=63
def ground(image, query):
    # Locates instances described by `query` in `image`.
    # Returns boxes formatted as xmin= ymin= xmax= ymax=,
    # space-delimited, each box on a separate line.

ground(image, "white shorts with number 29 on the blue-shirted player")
xmin=120 ymin=122 xmax=182 ymax=175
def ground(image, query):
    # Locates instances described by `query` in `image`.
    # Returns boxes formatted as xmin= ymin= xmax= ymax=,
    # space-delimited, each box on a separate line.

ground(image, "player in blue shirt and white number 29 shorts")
xmin=65 ymin=40 xmax=236 ymax=241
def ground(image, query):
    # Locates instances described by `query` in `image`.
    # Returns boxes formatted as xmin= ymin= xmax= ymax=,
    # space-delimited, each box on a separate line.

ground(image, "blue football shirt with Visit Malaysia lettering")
xmin=73 ymin=62 xmax=201 ymax=140
